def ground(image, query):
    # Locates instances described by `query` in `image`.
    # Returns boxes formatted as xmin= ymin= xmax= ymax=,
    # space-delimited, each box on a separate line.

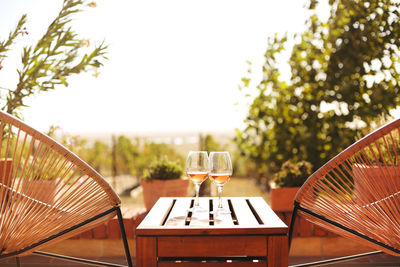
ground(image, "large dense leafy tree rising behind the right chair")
xmin=236 ymin=0 xmax=400 ymax=182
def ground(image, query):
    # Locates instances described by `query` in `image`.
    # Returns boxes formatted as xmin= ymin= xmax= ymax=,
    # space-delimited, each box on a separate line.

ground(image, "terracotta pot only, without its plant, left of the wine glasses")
xmin=141 ymin=179 xmax=189 ymax=213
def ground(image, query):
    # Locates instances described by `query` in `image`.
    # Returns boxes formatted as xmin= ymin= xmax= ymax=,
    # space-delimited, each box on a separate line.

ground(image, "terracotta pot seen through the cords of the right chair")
xmin=352 ymin=164 xmax=400 ymax=205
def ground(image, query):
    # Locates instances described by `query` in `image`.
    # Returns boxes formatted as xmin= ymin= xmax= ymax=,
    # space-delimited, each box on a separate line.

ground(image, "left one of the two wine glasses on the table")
xmin=186 ymin=151 xmax=209 ymax=211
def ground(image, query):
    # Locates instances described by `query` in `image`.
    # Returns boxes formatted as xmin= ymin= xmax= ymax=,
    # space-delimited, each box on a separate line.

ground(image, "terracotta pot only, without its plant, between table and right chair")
xmin=271 ymin=187 xmax=300 ymax=211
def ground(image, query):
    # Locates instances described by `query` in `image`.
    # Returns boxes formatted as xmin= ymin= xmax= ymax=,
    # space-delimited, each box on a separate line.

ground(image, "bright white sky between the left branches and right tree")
xmin=0 ymin=0 xmax=307 ymax=133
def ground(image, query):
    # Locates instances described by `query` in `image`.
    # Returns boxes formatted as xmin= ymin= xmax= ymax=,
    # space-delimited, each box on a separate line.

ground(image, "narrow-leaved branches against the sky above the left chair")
xmin=0 ymin=0 xmax=107 ymax=116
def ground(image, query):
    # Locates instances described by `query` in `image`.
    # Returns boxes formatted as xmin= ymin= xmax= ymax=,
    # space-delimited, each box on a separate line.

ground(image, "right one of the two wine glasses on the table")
xmin=209 ymin=151 xmax=232 ymax=214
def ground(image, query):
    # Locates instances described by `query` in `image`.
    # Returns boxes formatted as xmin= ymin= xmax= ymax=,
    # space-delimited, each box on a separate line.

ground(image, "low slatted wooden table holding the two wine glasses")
xmin=136 ymin=197 xmax=288 ymax=267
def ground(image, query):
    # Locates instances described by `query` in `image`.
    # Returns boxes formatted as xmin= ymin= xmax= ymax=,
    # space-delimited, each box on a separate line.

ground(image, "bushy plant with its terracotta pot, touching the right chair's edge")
xmin=271 ymin=161 xmax=312 ymax=211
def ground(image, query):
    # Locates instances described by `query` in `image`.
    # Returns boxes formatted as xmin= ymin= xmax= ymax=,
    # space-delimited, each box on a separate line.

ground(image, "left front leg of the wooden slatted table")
xmin=136 ymin=236 xmax=157 ymax=267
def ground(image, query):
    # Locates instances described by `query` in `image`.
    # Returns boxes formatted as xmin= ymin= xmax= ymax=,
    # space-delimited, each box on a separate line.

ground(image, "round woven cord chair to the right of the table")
xmin=289 ymin=119 xmax=400 ymax=266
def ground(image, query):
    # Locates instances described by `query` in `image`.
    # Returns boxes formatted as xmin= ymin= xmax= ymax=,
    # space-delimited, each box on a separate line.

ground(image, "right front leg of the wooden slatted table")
xmin=267 ymin=235 xmax=289 ymax=267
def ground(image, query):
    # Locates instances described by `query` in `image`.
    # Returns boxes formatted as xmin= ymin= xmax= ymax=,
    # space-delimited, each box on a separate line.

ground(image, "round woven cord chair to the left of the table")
xmin=0 ymin=111 xmax=132 ymax=266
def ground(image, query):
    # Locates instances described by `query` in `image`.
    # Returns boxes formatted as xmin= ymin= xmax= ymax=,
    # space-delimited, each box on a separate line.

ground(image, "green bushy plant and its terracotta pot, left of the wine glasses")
xmin=141 ymin=159 xmax=189 ymax=210
